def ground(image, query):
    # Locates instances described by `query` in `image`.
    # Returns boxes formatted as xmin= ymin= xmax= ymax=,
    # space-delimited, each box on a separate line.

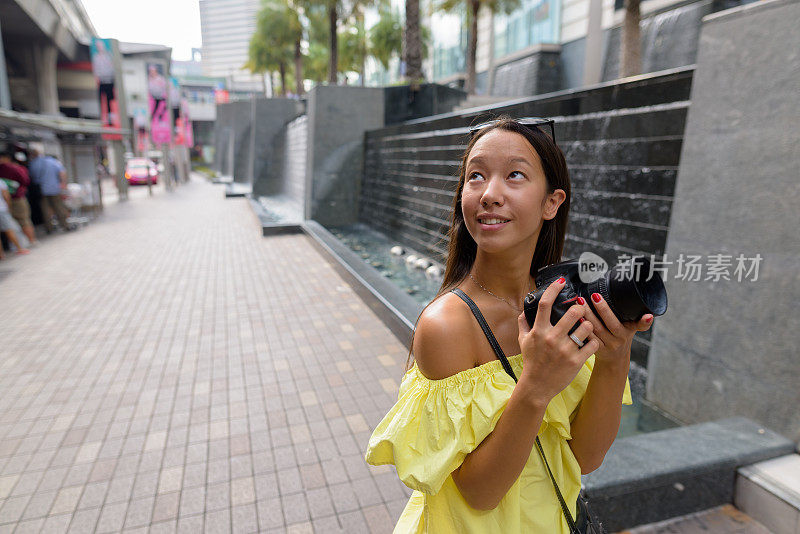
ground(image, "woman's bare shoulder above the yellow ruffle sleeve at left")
xmin=412 ymin=293 xmax=480 ymax=380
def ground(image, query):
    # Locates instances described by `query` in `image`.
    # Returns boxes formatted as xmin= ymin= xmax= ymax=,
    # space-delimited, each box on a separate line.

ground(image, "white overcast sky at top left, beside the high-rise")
xmin=81 ymin=0 xmax=201 ymax=60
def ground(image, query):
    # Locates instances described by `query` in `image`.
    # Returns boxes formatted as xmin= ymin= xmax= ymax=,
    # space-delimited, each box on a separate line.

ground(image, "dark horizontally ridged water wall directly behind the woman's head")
xmin=359 ymin=68 xmax=693 ymax=366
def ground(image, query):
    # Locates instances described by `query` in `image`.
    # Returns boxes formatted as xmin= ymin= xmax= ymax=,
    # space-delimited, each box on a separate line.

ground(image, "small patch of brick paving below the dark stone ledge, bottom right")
xmin=620 ymin=504 xmax=771 ymax=534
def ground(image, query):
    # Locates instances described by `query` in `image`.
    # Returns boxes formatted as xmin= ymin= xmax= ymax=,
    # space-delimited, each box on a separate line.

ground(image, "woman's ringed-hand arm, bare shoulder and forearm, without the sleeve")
xmin=414 ymin=283 xmax=599 ymax=510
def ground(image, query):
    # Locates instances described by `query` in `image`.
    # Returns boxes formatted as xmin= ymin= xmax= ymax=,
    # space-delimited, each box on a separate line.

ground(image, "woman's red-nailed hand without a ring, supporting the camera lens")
xmin=583 ymin=293 xmax=653 ymax=366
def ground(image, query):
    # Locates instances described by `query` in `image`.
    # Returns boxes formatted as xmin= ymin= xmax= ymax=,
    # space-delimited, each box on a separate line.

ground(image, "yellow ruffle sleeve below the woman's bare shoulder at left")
xmin=366 ymin=360 xmax=515 ymax=495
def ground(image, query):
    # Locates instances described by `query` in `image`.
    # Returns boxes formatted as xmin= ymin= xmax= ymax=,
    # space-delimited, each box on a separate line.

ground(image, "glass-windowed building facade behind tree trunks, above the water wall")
xmin=367 ymin=0 xmax=753 ymax=97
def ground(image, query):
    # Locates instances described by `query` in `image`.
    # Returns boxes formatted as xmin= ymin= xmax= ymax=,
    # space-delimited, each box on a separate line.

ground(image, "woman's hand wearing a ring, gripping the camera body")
xmin=517 ymin=278 xmax=601 ymax=406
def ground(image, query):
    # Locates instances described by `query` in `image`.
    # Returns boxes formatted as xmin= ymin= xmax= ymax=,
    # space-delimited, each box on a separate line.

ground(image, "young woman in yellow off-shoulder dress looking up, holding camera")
xmin=366 ymin=119 xmax=653 ymax=534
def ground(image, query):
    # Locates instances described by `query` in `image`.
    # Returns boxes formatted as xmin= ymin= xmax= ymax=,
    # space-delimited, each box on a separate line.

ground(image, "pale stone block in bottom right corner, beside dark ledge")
xmin=734 ymin=454 xmax=800 ymax=534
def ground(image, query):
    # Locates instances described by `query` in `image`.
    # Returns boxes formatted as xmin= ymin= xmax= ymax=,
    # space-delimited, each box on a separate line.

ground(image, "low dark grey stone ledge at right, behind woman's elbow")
xmin=583 ymin=417 xmax=795 ymax=532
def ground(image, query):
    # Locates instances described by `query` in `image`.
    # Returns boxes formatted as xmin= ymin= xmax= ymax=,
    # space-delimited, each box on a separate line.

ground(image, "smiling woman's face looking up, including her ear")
xmin=461 ymin=129 xmax=566 ymax=252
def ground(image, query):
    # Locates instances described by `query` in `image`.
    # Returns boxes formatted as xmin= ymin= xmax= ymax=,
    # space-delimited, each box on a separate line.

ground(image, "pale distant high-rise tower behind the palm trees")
xmin=200 ymin=0 xmax=264 ymax=91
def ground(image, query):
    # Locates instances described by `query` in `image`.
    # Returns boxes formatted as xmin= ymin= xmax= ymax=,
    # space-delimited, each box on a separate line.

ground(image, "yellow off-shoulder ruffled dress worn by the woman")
xmin=366 ymin=354 xmax=632 ymax=534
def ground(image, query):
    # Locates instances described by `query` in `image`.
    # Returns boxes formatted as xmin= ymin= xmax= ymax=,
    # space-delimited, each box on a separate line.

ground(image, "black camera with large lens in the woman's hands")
xmin=524 ymin=256 xmax=667 ymax=340
